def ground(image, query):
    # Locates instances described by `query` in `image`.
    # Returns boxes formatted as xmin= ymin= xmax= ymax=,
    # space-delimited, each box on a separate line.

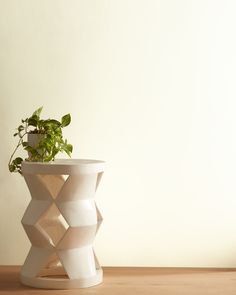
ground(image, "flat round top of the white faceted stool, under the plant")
xmin=22 ymin=159 xmax=105 ymax=175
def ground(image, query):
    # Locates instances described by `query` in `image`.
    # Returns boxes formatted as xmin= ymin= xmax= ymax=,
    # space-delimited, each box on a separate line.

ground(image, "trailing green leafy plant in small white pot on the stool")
xmin=8 ymin=107 xmax=73 ymax=174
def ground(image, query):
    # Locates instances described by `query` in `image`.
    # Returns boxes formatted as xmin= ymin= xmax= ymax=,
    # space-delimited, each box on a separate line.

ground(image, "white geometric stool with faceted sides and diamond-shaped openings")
xmin=20 ymin=159 xmax=105 ymax=289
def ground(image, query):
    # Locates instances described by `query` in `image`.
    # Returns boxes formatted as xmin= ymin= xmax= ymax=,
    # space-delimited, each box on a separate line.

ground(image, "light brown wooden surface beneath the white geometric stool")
xmin=0 ymin=266 xmax=236 ymax=295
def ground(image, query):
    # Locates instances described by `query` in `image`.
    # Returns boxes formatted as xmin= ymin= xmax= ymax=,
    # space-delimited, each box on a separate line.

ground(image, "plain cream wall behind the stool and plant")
xmin=0 ymin=0 xmax=236 ymax=267
